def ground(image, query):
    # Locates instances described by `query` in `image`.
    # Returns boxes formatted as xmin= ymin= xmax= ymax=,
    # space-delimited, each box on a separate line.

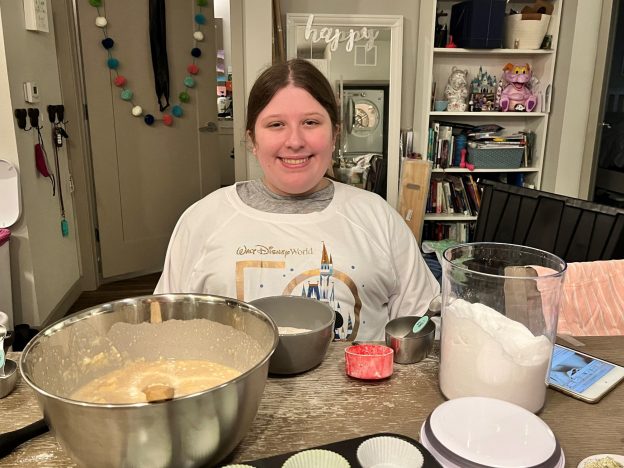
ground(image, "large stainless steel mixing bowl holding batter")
xmin=20 ymin=294 xmax=278 ymax=468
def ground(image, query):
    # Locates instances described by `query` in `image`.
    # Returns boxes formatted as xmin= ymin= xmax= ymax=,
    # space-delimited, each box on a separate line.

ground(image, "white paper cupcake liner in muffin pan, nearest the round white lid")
xmin=357 ymin=436 xmax=424 ymax=468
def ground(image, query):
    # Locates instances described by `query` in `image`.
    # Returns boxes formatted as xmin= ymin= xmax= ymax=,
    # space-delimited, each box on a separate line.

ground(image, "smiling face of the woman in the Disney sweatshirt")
xmin=252 ymin=84 xmax=335 ymax=195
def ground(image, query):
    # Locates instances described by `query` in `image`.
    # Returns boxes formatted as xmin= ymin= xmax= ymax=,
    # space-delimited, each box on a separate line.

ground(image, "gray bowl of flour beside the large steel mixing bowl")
xmin=251 ymin=296 xmax=336 ymax=375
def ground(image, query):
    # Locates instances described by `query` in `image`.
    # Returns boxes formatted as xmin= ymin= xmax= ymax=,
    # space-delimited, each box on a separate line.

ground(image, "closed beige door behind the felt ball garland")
xmin=53 ymin=0 xmax=221 ymax=289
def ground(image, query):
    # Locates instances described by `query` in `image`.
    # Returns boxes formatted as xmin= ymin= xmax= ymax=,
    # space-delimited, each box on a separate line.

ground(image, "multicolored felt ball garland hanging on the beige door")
xmin=88 ymin=0 xmax=208 ymax=127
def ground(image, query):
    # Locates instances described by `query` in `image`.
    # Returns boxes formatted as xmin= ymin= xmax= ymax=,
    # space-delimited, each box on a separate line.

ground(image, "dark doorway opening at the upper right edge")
xmin=593 ymin=0 xmax=624 ymax=209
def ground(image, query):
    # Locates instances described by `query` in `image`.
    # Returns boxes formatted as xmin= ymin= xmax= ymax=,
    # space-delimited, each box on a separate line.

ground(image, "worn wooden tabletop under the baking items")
xmin=0 ymin=336 xmax=624 ymax=467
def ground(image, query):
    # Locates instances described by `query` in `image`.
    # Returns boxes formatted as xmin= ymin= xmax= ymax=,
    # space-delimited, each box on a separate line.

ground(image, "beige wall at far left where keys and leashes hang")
xmin=0 ymin=0 xmax=80 ymax=325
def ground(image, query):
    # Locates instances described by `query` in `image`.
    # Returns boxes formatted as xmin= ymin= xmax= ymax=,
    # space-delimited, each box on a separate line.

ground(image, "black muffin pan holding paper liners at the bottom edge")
xmin=227 ymin=432 xmax=442 ymax=468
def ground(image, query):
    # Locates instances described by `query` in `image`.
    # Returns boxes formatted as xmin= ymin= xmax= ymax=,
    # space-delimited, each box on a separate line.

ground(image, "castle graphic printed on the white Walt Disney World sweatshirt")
xmin=301 ymin=242 xmax=355 ymax=340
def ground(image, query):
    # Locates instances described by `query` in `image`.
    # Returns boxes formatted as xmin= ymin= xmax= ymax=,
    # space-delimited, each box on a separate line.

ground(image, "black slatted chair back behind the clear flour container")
xmin=473 ymin=180 xmax=624 ymax=262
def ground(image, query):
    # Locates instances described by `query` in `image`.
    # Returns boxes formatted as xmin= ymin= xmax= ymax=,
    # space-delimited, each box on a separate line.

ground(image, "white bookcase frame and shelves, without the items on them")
xmin=414 ymin=0 xmax=561 ymax=240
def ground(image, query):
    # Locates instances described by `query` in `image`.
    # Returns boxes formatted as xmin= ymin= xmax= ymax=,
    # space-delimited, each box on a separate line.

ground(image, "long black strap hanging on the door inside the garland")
xmin=149 ymin=0 xmax=169 ymax=112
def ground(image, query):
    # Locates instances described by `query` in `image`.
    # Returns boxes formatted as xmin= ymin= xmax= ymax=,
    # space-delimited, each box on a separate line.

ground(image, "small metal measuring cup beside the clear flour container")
xmin=386 ymin=315 xmax=435 ymax=364
